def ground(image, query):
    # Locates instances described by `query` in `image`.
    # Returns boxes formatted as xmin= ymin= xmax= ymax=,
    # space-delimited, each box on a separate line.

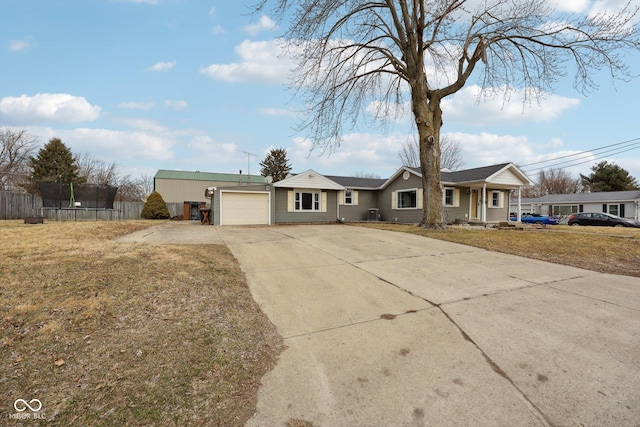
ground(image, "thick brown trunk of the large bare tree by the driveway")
xmin=412 ymin=85 xmax=443 ymax=228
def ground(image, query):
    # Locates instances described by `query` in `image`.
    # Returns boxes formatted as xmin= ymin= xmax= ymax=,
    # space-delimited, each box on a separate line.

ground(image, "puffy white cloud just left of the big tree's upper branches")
xmin=200 ymin=40 xmax=294 ymax=83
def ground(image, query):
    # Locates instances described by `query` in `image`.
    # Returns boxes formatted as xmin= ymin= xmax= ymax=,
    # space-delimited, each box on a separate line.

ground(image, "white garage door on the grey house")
xmin=220 ymin=192 xmax=269 ymax=225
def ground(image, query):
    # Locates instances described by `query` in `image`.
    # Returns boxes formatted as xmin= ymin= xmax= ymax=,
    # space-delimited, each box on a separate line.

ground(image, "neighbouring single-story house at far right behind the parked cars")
xmin=511 ymin=190 xmax=640 ymax=220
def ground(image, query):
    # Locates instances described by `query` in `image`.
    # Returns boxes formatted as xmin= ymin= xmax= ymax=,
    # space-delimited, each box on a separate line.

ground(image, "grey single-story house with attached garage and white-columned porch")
xmin=208 ymin=163 xmax=532 ymax=225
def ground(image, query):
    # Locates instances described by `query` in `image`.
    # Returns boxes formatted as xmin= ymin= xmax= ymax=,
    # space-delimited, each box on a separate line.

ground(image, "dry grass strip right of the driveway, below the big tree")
xmin=358 ymin=223 xmax=640 ymax=277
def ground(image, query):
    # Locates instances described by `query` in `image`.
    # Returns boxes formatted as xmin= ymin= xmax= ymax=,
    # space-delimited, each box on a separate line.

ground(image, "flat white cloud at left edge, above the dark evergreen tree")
xmin=0 ymin=93 xmax=101 ymax=124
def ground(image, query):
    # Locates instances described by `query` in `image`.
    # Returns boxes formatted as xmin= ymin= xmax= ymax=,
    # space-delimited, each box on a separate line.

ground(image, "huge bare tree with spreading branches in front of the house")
xmin=255 ymin=0 xmax=640 ymax=227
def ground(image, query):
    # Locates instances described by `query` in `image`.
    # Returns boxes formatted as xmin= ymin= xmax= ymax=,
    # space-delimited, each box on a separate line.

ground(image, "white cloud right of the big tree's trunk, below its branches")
xmin=442 ymin=85 xmax=580 ymax=125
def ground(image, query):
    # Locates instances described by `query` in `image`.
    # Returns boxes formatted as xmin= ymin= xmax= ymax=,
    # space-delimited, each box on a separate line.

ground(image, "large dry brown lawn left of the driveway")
xmin=0 ymin=221 xmax=282 ymax=426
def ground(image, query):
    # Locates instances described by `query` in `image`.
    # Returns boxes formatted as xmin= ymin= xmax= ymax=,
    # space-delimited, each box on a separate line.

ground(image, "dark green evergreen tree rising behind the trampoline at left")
xmin=28 ymin=138 xmax=86 ymax=194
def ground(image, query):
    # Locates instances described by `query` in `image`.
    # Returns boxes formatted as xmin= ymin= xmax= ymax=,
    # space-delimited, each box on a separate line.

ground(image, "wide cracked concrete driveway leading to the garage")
xmin=117 ymin=225 xmax=640 ymax=427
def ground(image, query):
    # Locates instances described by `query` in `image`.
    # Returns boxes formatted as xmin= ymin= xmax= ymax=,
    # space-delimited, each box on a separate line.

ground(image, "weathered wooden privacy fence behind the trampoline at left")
xmin=0 ymin=191 xmax=183 ymax=221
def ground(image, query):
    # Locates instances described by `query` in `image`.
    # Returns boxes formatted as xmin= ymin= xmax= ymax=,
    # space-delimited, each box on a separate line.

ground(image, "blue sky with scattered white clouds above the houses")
xmin=0 ymin=0 xmax=640 ymax=180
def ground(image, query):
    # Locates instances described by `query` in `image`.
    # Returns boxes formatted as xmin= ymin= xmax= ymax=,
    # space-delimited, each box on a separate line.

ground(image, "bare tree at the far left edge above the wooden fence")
xmin=0 ymin=128 xmax=37 ymax=191
